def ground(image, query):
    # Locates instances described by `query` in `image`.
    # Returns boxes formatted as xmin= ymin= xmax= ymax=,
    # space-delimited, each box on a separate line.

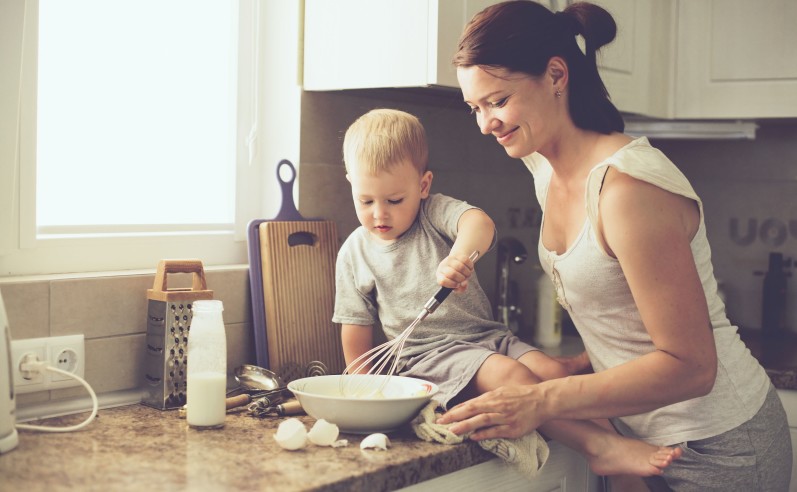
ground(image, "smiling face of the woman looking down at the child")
xmin=457 ymin=66 xmax=564 ymax=158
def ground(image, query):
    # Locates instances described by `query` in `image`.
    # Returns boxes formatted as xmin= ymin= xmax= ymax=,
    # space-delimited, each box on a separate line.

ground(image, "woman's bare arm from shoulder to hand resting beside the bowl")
xmin=441 ymin=173 xmax=717 ymax=439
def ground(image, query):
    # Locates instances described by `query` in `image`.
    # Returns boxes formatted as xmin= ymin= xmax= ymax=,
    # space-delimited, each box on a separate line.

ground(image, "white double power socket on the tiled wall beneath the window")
xmin=11 ymin=335 xmax=86 ymax=393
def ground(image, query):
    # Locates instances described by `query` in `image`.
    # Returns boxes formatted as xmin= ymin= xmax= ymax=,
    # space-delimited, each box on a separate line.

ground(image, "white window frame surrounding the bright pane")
xmin=0 ymin=0 xmax=303 ymax=277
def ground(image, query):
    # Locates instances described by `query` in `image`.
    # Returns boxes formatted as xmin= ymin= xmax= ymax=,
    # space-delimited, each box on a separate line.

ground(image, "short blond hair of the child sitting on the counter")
xmin=343 ymin=109 xmax=429 ymax=175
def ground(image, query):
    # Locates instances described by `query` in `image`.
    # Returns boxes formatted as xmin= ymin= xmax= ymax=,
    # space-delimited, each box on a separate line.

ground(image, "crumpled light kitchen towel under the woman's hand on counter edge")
xmin=412 ymin=400 xmax=550 ymax=478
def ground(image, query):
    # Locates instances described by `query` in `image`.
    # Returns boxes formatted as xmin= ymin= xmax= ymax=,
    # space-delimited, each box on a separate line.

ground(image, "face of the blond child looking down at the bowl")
xmin=346 ymin=161 xmax=432 ymax=242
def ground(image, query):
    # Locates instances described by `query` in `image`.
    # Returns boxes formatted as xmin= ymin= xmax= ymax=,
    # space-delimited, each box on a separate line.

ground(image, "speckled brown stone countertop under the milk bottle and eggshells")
xmin=0 ymin=405 xmax=494 ymax=492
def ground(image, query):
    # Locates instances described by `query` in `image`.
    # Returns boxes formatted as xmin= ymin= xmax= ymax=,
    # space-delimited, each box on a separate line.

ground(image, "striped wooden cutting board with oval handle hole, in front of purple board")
xmin=260 ymin=220 xmax=346 ymax=374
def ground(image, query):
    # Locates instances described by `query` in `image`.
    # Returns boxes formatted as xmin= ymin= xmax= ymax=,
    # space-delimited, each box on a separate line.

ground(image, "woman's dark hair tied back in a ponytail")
xmin=453 ymin=0 xmax=625 ymax=134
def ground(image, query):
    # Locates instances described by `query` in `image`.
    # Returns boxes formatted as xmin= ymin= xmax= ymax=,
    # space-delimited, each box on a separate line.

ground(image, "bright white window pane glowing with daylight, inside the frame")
xmin=36 ymin=0 xmax=238 ymax=235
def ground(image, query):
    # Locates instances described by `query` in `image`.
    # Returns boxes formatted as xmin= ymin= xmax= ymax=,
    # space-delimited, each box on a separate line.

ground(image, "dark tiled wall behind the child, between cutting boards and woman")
xmin=299 ymin=89 xmax=541 ymax=338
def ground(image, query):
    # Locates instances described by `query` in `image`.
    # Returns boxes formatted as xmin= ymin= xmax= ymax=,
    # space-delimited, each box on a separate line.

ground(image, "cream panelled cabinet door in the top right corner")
xmin=676 ymin=0 xmax=797 ymax=118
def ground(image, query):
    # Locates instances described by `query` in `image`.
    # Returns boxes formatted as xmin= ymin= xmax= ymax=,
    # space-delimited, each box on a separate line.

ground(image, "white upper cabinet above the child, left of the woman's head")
xmin=303 ymin=0 xmax=497 ymax=90
